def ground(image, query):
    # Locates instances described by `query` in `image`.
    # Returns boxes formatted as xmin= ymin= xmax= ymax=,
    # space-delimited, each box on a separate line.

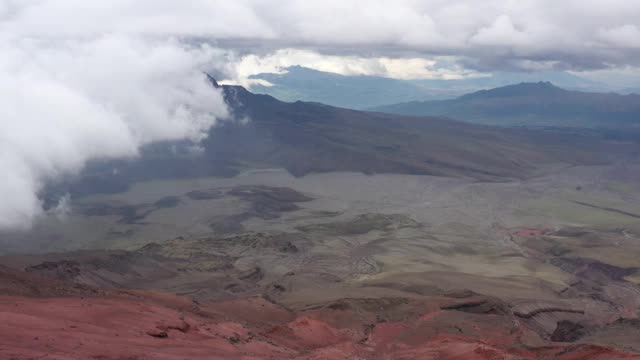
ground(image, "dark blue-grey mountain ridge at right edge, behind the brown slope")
xmin=370 ymin=82 xmax=640 ymax=128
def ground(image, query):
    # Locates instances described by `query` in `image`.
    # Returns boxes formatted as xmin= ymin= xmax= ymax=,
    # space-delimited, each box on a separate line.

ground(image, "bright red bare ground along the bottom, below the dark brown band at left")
xmin=0 ymin=293 xmax=639 ymax=360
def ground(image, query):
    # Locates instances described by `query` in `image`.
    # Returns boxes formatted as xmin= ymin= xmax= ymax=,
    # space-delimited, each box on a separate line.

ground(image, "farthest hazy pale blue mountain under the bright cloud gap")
xmin=251 ymin=66 xmax=605 ymax=109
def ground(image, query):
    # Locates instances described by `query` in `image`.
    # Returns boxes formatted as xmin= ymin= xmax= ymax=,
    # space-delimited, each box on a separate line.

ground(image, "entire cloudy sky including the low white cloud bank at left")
xmin=0 ymin=0 xmax=640 ymax=229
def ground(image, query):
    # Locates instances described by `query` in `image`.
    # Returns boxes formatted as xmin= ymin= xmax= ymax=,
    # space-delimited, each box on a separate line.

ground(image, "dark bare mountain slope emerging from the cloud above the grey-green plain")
xmin=42 ymin=79 xmax=628 ymax=206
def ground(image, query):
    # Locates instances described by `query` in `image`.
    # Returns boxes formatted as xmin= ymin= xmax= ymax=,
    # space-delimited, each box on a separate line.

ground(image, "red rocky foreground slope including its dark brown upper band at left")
xmin=0 ymin=268 xmax=640 ymax=360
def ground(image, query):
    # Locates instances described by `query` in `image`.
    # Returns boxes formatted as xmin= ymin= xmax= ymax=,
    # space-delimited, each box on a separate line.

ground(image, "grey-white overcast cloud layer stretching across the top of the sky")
xmin=5 ymin=0 xmax=640 ymax=70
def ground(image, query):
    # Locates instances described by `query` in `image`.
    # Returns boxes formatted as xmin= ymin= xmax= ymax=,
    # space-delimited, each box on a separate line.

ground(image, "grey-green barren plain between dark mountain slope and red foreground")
xmin=2 ymin=162 xmax=640 ymax=359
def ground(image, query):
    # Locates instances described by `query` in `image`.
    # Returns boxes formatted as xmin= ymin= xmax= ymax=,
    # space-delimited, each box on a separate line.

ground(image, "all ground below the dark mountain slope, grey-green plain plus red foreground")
xmin=0 ymin=163 xmax=640 ymax=359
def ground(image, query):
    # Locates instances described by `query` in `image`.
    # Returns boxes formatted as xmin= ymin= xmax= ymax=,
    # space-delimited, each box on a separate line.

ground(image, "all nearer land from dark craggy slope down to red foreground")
xmin=7 ymin=74 xmax=640 ymax=360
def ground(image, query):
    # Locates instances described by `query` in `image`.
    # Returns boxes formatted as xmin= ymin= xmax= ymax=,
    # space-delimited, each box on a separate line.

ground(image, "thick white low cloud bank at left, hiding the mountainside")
xmin=0 ymin=36 xmax=226 ymax=229
